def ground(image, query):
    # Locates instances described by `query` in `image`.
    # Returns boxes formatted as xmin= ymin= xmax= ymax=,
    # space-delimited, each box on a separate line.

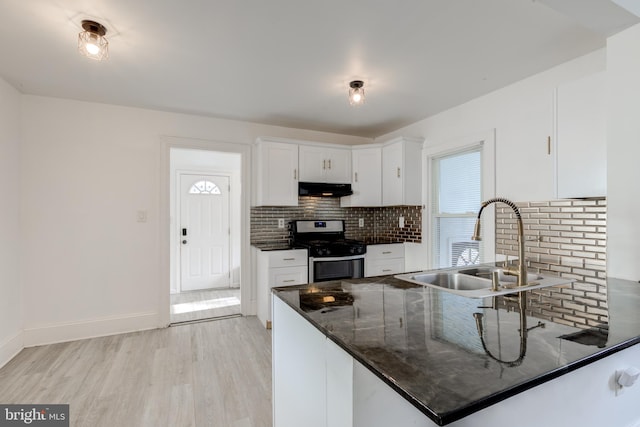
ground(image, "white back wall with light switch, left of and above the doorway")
xmin=20 ymin=96 xmax=371 ymax=346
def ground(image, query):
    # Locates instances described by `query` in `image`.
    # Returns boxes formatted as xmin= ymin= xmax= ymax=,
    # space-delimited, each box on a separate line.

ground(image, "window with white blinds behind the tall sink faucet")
xmin=431 ymin=145 xmax=482 ymax=268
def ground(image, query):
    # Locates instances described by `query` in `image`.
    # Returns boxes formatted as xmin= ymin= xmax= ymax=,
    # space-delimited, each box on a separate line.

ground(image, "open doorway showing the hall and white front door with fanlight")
xmin=169 ymin=148 xmax=242 ymax=324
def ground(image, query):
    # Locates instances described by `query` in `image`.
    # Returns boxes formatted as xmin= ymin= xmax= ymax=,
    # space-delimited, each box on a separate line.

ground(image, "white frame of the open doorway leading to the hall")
xmin=158 ymin=136 xmax=251 ymax=327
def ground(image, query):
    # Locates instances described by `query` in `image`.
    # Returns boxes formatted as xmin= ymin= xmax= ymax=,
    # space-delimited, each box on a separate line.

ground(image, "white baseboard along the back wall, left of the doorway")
xmin=24 ymin=312 xmax=160 ymax=347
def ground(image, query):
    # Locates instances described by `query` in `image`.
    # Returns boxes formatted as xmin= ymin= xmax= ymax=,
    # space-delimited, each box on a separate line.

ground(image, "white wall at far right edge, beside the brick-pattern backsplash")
xmin=607 ymin=24 xmax=640 ymax=281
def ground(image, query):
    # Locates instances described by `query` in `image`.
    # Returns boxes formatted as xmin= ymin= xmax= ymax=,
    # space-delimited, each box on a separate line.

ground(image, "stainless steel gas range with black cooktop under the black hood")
xmin=291 ymin=220 xmax=367 ymax=283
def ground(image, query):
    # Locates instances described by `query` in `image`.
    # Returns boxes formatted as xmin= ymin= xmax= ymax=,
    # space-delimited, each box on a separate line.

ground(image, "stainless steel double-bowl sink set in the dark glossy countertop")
xmin=395 ymin=266 xmax=574 ymax=298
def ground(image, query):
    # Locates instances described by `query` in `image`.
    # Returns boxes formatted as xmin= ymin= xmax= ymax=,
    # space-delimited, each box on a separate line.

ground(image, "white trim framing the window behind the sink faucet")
xmin=422 ymin=129 xmax=496 ymax=269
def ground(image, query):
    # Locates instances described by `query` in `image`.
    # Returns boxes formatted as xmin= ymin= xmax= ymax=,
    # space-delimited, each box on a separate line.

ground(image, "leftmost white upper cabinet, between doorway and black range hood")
xmin=254 ymin=138 xmax=298 ymax=206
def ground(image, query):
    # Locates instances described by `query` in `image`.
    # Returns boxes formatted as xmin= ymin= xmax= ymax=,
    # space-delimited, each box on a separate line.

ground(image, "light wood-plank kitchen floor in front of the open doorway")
xmin=0 ymin=316 xmax=272 ymax=427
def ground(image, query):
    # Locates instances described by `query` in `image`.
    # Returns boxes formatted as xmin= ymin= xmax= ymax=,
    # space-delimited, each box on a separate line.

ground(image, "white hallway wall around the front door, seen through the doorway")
xmin=169 ymin=148 xmax=241 ymax=293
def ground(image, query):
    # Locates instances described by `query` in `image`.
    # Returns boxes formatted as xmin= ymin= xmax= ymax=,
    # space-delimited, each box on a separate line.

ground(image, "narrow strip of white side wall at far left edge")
xmin=0 ymin=74 xmax=22 ymax=366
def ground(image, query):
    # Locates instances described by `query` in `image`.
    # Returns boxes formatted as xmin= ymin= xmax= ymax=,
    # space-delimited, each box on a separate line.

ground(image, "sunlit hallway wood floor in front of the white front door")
xmin=171 ymin=288 xmax=240 ymax=323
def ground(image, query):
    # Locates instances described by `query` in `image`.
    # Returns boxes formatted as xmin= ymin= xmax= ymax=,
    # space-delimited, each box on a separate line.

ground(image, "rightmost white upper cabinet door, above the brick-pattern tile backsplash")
xmin=556 ymin=72 xmax=607 ymax=199
